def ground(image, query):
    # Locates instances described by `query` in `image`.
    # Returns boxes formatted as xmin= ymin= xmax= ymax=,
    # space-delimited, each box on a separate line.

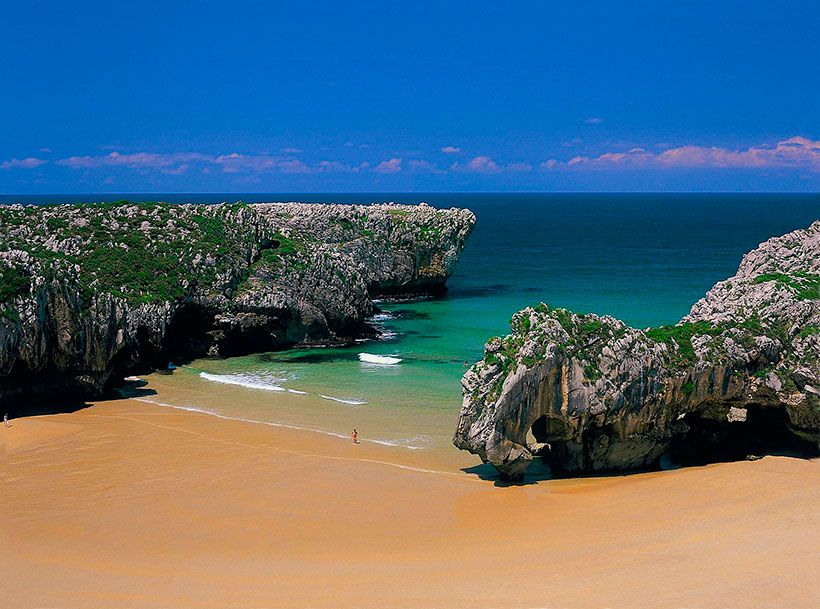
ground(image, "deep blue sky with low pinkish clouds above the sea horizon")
xmin=0 ymin=0 xmax=820 ymax=193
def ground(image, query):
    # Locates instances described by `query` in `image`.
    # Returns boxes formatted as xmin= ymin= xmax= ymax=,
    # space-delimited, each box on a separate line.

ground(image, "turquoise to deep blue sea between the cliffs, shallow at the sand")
xmin=135 ymin=194 xmax=820 ymax=451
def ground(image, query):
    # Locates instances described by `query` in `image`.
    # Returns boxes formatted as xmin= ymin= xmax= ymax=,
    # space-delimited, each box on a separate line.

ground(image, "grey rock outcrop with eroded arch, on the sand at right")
xmin=454 ymin=222 xmax=820 ymax=480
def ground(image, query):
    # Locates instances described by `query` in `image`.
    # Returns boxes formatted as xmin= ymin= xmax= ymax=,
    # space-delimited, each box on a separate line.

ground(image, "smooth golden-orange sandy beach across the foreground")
xmin=0 ymin=400 xmax=820 ymax=609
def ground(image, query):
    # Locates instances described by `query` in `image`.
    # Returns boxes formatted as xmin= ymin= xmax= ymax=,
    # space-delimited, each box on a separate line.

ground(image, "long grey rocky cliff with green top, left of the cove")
xmin=0 ymin=202 xmax=475 ymax=403
